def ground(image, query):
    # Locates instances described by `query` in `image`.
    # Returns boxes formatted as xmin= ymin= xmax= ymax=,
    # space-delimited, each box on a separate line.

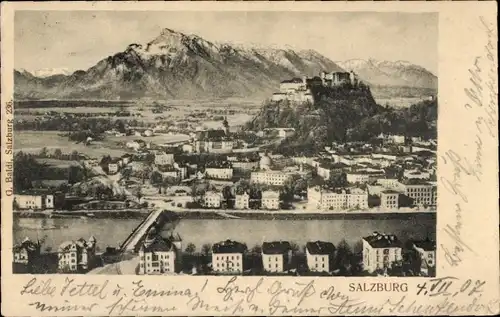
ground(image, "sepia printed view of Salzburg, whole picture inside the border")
xmin=11 ymin=10 xmax=441 ymax=276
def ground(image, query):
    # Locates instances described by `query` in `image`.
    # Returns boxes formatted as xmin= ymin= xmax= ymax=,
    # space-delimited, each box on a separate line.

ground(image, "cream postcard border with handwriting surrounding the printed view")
xmin=1 ymin=2 xmax=500 ymax=316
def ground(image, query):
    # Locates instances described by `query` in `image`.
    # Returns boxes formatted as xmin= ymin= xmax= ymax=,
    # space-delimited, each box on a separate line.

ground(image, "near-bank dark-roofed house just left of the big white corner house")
xmin=306 ymin=241 xmax=335 ymax=272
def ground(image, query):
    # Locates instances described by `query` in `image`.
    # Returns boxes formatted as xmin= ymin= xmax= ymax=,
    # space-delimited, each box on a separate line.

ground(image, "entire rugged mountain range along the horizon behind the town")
xmin=14 ymin=29 xmax=437 ymax=100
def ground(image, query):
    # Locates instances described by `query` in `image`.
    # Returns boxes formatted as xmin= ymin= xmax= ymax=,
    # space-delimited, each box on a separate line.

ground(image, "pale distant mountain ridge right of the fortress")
xmin=336 ymin=59 xmax=438 ymax=89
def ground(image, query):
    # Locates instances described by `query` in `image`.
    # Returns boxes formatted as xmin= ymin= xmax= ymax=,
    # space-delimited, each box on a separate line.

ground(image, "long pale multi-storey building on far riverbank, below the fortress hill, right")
xmin=307 ymin=186 xmax=368 ymax=210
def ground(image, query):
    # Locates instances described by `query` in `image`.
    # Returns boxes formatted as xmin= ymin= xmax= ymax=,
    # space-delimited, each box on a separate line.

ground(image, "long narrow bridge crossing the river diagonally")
xmin=120 ymin=209 xmax=180 ymax=253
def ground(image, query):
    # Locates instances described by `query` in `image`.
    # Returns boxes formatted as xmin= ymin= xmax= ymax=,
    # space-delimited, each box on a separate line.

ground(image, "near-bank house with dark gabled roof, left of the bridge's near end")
xmin=58 ymin=236 xmax=96 ymax=272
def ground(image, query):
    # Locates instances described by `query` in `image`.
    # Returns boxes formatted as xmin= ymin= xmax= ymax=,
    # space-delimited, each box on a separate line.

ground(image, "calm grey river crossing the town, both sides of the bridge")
xmin=14 ymin=214 xmax=436 ymax=251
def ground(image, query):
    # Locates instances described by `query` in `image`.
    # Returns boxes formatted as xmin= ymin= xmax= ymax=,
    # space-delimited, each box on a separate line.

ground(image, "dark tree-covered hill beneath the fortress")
xmin=246 ymin=87 xmax=437 ymax=150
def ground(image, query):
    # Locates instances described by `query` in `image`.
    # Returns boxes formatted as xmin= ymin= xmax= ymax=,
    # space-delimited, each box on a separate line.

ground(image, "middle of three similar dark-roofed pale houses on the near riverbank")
xmin=262 ymin=241 xmax=293 ymax=273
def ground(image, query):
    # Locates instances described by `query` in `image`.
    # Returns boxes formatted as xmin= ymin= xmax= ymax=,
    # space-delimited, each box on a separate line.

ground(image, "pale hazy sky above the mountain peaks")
xmin=14 ymin=11 xmax=438 ymax=75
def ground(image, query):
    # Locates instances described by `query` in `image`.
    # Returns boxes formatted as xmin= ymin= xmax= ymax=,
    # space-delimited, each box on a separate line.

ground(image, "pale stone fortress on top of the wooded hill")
xmin=271 ymin=71 xmax=364 ymax=103
